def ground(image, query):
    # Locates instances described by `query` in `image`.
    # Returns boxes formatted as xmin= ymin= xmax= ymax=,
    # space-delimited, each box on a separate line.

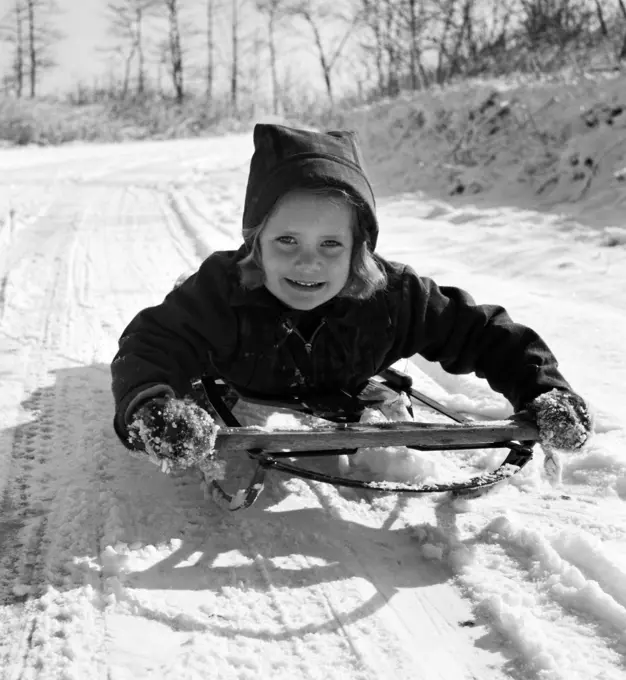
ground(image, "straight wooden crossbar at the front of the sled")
xmin=215 ymin=420 xmax=538 ymax=454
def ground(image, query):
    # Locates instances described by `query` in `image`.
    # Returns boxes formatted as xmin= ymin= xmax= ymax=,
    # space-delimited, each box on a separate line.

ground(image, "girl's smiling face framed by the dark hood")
xmin=259 ymin=190 xmax=355 ymax=310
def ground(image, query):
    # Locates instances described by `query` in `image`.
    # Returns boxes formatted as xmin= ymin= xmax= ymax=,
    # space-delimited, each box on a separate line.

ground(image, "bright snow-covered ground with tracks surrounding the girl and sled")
xmin=0 ymin=135 xmax=626 ymax=680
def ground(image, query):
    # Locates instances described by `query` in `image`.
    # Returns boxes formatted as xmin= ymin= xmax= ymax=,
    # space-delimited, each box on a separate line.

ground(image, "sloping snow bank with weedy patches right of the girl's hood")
xmin=337 ymin=75 xmax=626 ymax=228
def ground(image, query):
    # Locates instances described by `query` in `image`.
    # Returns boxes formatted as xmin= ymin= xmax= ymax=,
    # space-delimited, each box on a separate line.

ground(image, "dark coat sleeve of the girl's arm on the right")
xmin=399 ymin=267 xmax=571 ymax=410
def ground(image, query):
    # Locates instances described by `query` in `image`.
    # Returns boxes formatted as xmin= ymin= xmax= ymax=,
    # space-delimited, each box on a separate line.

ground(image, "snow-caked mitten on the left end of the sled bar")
xmin=128 ymin=397 xmax=217 ymax=472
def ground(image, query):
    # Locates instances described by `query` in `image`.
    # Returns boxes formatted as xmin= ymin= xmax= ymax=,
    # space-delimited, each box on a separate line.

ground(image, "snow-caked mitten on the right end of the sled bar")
xmin=527 ymin=389 xmax=593 ymax=452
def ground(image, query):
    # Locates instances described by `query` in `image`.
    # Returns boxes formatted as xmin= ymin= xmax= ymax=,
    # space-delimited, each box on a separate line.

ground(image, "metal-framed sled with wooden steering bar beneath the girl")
xmin=201 ymin=368 xmax=538 ymax=510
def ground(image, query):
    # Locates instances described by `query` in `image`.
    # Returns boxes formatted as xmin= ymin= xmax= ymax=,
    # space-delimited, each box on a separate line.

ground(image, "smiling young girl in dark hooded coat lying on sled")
xmin=111 ymin=125 xmax=591 ymax=466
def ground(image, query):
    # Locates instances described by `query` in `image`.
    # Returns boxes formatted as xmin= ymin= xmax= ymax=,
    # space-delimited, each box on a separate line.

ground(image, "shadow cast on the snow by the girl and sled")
xmin=0 ymin=364 xmax=498 ymax=652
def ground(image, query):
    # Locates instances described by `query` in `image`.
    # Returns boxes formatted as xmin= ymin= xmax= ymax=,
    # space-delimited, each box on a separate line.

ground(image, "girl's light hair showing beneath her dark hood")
xmin=238 ymin=185 xmax=387 ymax=300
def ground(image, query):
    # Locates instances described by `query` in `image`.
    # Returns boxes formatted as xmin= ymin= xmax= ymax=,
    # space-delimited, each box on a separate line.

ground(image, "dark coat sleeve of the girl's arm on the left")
xmin=111 ymin=256 xmax=237 ymax=444
